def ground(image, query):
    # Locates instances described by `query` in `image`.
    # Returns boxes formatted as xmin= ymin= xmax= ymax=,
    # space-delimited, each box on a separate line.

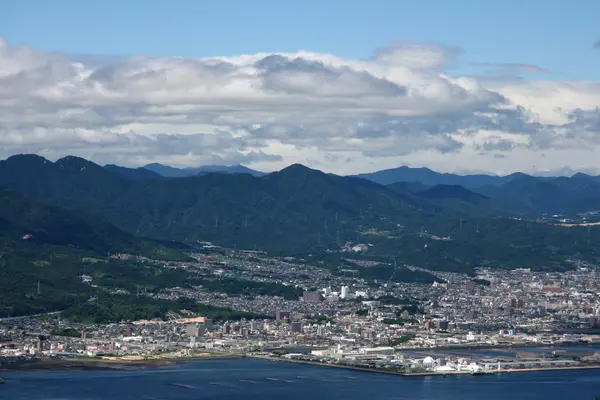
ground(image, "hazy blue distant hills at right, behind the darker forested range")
xmin=358 ymin=167 xmax=600 ymax=217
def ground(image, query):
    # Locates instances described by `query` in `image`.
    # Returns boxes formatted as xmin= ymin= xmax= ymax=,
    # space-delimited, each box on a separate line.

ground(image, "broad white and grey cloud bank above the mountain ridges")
xmin=0 ymin=38 xmax=600 ymax=173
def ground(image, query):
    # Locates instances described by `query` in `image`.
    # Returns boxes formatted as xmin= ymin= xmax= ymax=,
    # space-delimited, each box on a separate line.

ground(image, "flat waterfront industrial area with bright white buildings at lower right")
xmin=247 ymin=346 xmax=600 ymax=377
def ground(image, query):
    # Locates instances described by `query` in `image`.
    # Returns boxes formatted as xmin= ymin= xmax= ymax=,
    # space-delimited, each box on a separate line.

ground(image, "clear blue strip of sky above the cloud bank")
xmin=0 ymin=0 xmax=600 ymax=80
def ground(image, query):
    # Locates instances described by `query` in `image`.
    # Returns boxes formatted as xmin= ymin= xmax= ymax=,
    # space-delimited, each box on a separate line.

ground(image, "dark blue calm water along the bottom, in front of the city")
xmin=0 ymin=359 xmax=600 ymax=400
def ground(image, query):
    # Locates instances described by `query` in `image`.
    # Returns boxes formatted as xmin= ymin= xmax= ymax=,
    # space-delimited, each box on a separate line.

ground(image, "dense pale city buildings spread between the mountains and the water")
xmin=0 ymin=243 xmax=600 ymax=374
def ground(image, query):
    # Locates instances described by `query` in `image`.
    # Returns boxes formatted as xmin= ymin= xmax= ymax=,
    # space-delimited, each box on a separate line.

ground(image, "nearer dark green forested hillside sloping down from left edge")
xmin=0 ymin=188 xmax=187 ymax=317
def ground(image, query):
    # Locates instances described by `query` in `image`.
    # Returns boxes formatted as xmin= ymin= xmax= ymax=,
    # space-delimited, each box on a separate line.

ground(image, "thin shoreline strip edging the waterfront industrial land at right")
xmin=247 ymin=355 xmax=600 ymax=377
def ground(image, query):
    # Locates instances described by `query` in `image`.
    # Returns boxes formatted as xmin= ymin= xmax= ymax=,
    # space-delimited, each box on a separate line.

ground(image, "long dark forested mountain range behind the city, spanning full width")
xmin=0 ymin=155 xmax=600 ymax=279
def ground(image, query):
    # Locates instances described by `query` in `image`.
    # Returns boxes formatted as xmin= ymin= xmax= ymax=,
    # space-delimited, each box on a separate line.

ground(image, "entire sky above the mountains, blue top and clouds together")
xmin=0 ymin=0 xmax=600 ymax=175
